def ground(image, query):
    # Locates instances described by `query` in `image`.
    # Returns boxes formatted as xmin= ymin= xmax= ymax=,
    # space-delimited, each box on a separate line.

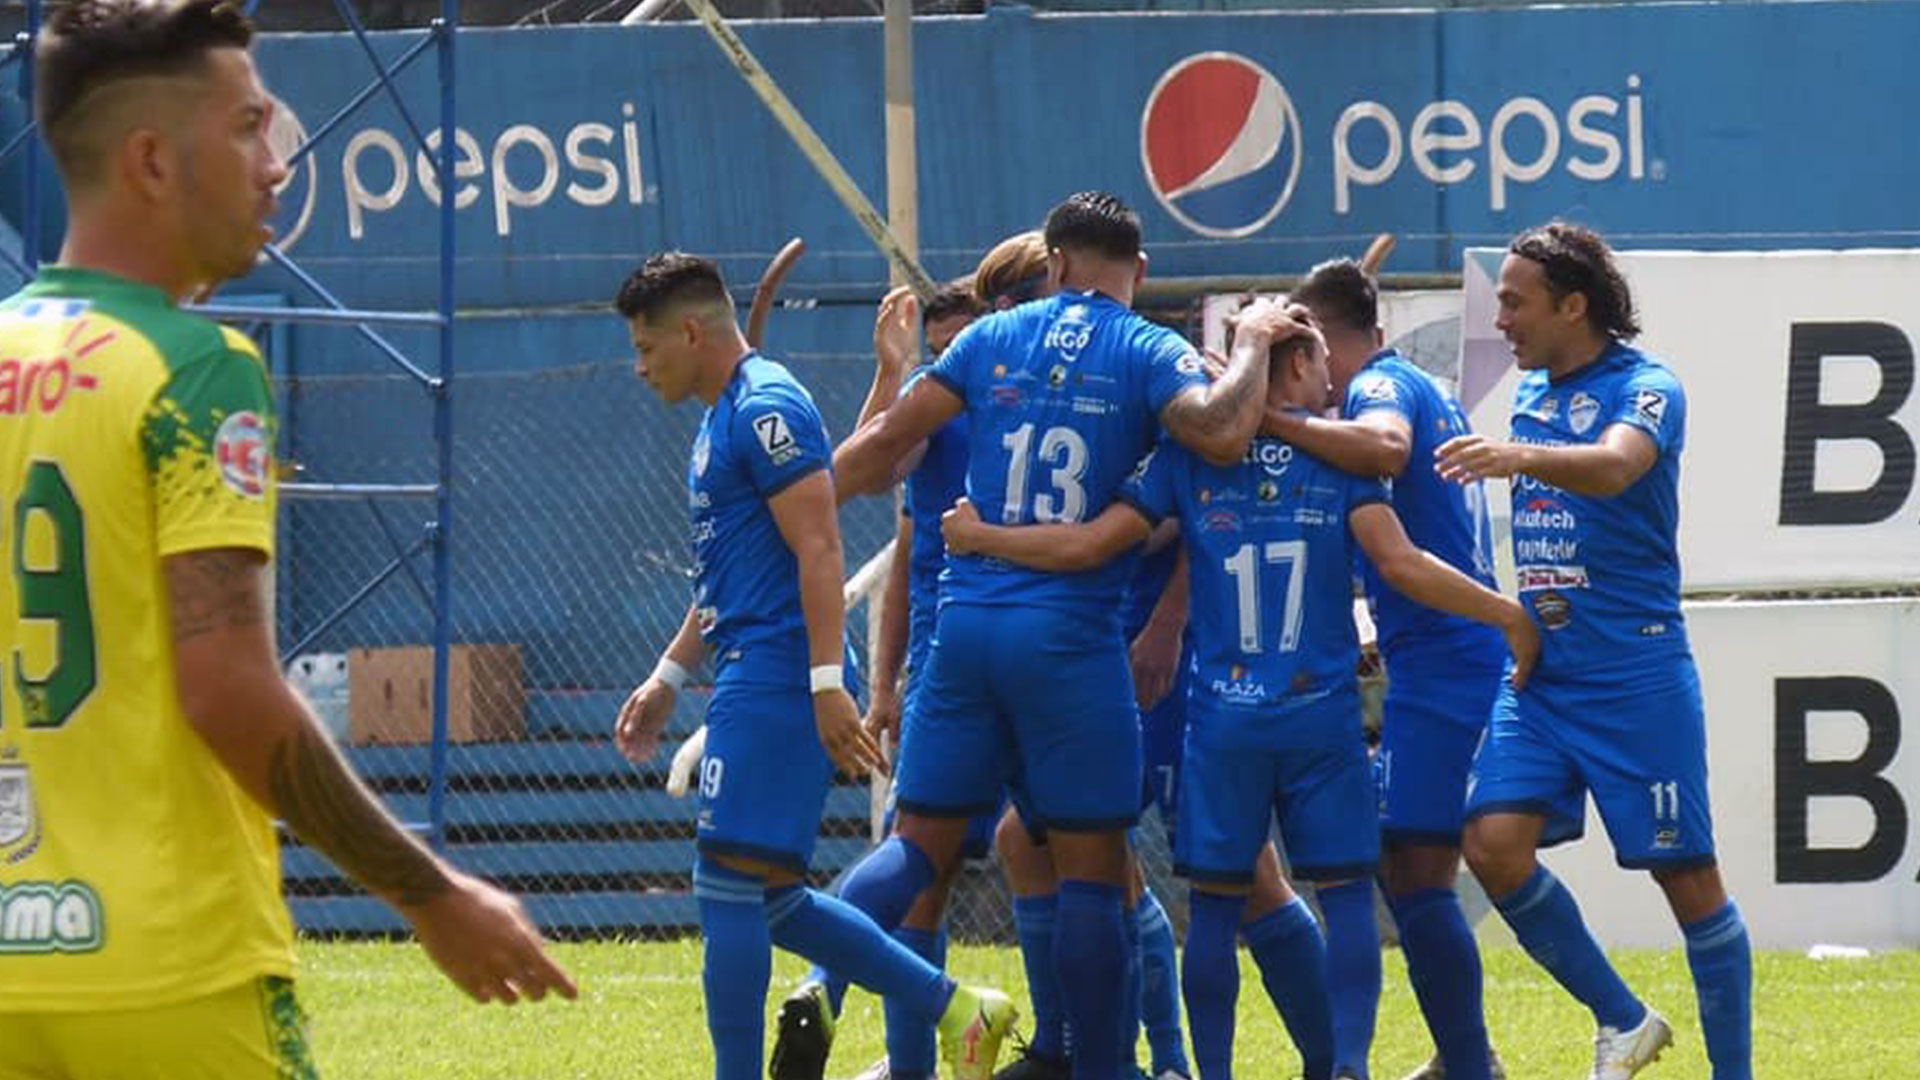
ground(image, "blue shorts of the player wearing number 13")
xmin=899 ymin=603 xmax=1140 ymax=832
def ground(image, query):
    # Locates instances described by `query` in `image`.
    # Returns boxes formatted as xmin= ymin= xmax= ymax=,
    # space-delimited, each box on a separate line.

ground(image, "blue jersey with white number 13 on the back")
xmin=929 ymin=292 xmax=1206 ymax=619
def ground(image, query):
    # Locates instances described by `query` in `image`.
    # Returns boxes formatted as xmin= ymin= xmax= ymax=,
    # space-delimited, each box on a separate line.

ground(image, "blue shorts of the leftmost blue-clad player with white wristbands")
xmin=695 ymin=675 xmax=833 ymax=872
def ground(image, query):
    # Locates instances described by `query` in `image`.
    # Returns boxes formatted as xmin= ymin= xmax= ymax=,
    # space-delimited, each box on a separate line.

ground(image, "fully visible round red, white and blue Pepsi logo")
xmin=1140 ymin=52 xmax=1300 ymax=238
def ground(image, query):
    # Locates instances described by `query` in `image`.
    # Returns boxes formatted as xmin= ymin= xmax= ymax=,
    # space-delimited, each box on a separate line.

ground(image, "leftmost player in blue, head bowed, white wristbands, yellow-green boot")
xmin=614 ymin=252 xmax=1014 ymax=1080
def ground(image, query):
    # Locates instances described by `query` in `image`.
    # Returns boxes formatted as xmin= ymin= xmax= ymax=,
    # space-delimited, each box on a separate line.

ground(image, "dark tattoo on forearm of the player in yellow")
xmin=267 ymin=724 xmax=451 ymax=907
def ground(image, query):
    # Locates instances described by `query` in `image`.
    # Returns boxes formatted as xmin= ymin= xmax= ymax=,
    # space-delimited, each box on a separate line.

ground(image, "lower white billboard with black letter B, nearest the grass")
xmin=1546 ymin=600 xmax=1920 ymax=949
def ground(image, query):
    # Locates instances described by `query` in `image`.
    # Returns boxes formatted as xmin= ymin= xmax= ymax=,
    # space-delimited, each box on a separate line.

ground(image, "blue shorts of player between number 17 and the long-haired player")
xmin=1373 ymin=663 xmax=1505 ymax=847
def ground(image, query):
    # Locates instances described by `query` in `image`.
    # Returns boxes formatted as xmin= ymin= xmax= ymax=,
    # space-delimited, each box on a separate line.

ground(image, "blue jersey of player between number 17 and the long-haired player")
xmin=1342 ymin=350 xmax=1505 ymax=663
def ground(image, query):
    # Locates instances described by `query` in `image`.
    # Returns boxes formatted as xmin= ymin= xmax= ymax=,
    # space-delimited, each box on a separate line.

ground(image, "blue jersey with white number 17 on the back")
xmin=1121 ymin=438 xmax=1388 ymax=748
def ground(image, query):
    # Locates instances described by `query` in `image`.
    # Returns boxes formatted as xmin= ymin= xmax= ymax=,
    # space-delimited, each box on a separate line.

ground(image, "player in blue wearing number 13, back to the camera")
xmin=835 ymin=192 xmax=1292 ymax=1080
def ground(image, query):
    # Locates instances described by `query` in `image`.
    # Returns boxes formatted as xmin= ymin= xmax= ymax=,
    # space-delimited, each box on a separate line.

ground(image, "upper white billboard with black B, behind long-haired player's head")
xmin=1461 ymin=248 xmax=1920 ymax=592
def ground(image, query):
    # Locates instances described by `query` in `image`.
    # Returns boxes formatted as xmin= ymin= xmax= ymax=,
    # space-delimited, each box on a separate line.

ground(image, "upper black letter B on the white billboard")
xmin=1780 ymin=323 xmax=1914 ymax=525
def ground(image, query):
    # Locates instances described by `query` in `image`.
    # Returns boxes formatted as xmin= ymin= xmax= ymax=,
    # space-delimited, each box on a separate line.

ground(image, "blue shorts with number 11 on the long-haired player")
xmin=1467 ymin=659 xmax=1715 ymax=869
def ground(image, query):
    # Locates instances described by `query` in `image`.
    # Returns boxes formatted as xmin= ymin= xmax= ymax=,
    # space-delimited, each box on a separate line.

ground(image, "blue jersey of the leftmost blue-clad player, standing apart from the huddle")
xmin=687 ymin=354 xmax=831 ymax=684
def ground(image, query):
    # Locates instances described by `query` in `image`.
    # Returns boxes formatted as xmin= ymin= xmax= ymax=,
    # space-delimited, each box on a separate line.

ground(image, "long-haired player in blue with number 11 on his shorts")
xmin=1438 ymin=223 xmax=1753 ymax=1080
